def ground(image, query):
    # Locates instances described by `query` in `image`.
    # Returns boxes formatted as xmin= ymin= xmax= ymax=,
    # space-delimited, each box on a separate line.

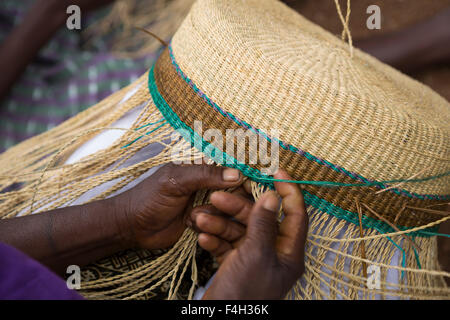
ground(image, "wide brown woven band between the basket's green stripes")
xmin=154 ymin=49 xmax=445 ymax=227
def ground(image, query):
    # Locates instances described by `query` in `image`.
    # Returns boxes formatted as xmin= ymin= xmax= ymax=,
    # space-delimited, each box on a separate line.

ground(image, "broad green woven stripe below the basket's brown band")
xmin=148 ymin=66 xmax=436 ymax=237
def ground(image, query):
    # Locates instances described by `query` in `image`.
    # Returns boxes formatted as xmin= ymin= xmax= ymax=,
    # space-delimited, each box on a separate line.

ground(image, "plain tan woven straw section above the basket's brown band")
xmin=172 ymin=0 xmax=450 ymax=195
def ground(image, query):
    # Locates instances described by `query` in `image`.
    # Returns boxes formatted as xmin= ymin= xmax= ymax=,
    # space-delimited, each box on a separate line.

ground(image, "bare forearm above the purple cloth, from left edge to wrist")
xmin=0 ymin=200 xmax=133 ymax=274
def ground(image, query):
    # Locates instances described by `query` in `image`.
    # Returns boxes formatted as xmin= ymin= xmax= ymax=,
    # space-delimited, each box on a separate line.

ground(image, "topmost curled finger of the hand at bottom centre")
xmin=209 ymin=191 xmax=254 ymax=225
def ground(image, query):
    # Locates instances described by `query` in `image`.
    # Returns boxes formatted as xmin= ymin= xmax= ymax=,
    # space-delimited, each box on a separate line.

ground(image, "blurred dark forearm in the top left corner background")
xmin=0 ymin=1 xmax=64 ymax=100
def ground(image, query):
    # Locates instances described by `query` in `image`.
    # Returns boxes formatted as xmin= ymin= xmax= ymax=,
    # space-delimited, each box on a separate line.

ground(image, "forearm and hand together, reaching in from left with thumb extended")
xmin=0 ymin=165 xmax=242 ymax=274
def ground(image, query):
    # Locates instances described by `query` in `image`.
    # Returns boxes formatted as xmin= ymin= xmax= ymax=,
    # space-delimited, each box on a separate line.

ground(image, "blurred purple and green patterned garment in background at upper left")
xmin=0 ymin=0 xmax=161 ymax=152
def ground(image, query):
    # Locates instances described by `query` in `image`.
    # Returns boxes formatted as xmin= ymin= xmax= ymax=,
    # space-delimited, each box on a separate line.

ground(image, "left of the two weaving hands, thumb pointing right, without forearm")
xmin=111 ymin=164 xmax=242 ymax=249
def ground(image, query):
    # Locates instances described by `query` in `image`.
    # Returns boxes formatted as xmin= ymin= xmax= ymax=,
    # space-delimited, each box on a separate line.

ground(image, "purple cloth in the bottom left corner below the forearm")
xmin=0 ymin=243 xmax=83 ymax=300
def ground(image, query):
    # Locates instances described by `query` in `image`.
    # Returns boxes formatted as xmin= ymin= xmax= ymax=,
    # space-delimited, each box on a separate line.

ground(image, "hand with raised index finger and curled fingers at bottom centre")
xmin=194 ymin=171 xmax=308 ymax=299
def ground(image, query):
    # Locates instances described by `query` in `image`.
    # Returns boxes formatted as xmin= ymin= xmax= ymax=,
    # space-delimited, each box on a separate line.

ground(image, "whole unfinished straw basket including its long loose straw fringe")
xmin=0 ymin=0 xmax=450 ymax=299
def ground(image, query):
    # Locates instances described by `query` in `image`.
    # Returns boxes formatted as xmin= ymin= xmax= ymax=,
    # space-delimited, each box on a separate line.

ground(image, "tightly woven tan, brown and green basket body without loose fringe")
xmin=150 ymin=0 xmax=450 ymax=227
